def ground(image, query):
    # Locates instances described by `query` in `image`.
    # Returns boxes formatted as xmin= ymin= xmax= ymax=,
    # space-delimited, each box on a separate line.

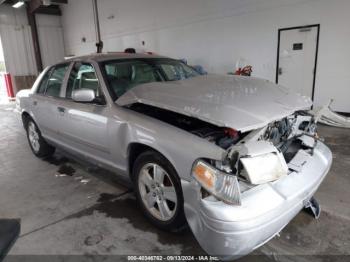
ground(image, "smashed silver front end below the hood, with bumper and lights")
xmin=182 ymin=111 xmax=332 ymax=259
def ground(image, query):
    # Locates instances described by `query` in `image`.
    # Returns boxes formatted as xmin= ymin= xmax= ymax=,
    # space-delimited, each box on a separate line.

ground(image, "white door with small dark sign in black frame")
xmin=277 ymin=26 xmax=319 ymax=99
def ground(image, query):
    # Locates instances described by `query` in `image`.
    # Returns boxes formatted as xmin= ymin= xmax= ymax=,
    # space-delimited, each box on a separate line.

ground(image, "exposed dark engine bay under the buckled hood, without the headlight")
xmin=128 ymin=103 xmax=316 ymax=158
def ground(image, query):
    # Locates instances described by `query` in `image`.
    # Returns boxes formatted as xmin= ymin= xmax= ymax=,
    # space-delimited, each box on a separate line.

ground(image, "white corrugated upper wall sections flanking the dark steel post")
xmin=0 ymin=4 xmax=64 ymax=76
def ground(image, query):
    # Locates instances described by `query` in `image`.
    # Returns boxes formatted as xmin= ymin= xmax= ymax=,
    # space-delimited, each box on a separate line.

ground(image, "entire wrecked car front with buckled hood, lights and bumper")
xmin=116 ymin=72 xmax=332 ymax=258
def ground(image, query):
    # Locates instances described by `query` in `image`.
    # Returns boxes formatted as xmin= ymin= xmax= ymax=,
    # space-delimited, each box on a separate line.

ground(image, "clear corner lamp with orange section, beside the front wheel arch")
xmin=192 ymin=160 xmax=241 ymax=205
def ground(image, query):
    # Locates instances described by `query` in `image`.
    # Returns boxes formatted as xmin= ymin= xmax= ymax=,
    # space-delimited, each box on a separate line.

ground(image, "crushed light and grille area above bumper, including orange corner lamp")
xmin=192 ymin=112 xmax=318 ymax=205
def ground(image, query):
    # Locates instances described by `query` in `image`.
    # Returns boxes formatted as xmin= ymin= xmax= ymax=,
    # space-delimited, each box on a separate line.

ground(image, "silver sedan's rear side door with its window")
xmin=32 ymin=63 xmax=69 ymax=141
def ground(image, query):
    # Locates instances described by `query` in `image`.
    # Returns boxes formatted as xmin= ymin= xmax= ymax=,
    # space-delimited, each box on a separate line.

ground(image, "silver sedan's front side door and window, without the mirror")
xmin=58 ymin=62 xmax=111 ymax=162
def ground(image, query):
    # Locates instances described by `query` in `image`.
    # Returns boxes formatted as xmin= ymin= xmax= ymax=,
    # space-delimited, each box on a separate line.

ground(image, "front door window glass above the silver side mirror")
xmin=66 ymin=63 xmax=103 ymax=101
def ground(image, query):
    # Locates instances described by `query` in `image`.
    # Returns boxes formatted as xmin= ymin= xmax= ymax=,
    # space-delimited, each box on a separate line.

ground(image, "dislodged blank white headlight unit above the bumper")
xmin=240 ymin=152 xmax=288 ymax=185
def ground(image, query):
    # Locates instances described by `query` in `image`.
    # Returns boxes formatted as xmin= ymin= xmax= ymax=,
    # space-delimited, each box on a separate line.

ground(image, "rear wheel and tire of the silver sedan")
xmin=26 ymin=118 xmax=55 ymax=158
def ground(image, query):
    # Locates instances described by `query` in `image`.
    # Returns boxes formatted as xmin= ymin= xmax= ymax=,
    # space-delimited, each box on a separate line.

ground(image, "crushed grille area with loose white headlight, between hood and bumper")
xmin=227 ymin=112 xmax=318 ymax=185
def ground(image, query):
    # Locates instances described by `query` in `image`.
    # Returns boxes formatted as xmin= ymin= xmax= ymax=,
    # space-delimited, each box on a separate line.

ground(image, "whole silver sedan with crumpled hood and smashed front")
xmin=16 ymin=54 xmax=332 ymax=258
